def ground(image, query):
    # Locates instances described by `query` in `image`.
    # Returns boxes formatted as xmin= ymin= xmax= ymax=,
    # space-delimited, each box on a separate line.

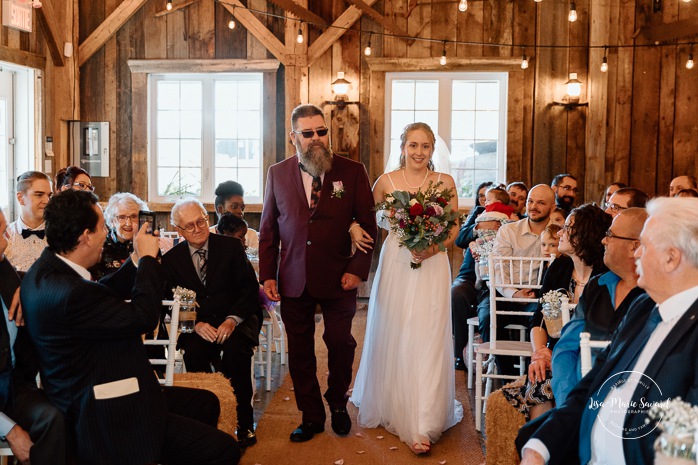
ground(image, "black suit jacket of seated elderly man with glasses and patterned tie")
xmin=162 ymin=234 xmax=260 ymax=346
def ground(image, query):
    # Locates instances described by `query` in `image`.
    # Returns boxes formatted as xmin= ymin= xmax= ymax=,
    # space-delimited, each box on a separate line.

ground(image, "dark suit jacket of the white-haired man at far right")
xmin=532 ymin=295 xmax=698 ymax=465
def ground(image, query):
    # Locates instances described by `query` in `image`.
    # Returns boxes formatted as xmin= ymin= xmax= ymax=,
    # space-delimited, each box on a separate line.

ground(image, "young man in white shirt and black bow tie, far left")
xmin=5 ymin=171 xmax=52 ymax=271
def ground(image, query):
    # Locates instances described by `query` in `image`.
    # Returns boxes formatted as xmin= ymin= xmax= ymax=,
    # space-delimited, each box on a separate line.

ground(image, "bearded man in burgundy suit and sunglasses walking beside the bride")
xmin=259 ymin=105 xmax=377 ymax=442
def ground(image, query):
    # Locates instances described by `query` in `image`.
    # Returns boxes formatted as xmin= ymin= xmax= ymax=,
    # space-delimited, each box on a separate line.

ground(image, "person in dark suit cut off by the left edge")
xmin=0 ymin=209 xmax=66 ymax=465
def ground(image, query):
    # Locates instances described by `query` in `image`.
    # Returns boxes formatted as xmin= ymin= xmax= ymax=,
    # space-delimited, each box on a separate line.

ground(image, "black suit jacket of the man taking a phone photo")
xmin=21 ymin=249 xmax=167 ymax=464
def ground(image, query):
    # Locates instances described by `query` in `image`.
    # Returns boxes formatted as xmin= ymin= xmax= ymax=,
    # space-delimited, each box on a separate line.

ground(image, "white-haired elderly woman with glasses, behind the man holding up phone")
xmin=90 ymin=192 xmax=148 ymax=279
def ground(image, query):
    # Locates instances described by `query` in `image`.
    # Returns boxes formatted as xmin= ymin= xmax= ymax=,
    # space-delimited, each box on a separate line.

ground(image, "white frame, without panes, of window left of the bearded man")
xmin=148 ymin=71 xmax=266 ymax=204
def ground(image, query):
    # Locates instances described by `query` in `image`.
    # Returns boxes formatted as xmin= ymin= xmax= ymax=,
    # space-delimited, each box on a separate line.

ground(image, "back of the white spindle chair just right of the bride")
xmin=489 ymin=255 xmax=554 ymax=346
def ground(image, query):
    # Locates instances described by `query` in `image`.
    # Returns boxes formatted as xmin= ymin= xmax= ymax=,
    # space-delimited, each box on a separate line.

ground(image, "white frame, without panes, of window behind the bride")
xmin=383 ymin=71 xmax=502 ymax=207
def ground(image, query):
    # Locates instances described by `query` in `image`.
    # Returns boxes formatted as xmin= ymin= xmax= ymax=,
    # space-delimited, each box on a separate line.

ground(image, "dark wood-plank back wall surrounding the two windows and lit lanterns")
xmin=73 ymin=0 xmax=698 ymax=208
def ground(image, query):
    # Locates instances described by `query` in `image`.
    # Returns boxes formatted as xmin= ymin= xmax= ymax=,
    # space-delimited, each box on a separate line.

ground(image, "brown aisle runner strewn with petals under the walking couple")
xmin=240 ymin=305 xmax=485 ymax=465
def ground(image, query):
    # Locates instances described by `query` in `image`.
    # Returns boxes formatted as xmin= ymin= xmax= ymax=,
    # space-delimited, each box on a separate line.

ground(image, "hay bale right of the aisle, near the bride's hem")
xmin=485 ymin=389 xmax=526 ymax=465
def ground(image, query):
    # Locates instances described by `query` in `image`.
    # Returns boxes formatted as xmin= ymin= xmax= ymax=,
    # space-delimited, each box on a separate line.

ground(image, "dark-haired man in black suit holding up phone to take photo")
xmin=21 ymin=190 xmax=239 ymax=465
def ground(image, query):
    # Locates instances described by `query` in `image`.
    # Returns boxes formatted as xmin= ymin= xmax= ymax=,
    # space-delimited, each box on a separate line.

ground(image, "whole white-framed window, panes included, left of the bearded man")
xmin=149 ymin=73 xmax=263 ymax=203
